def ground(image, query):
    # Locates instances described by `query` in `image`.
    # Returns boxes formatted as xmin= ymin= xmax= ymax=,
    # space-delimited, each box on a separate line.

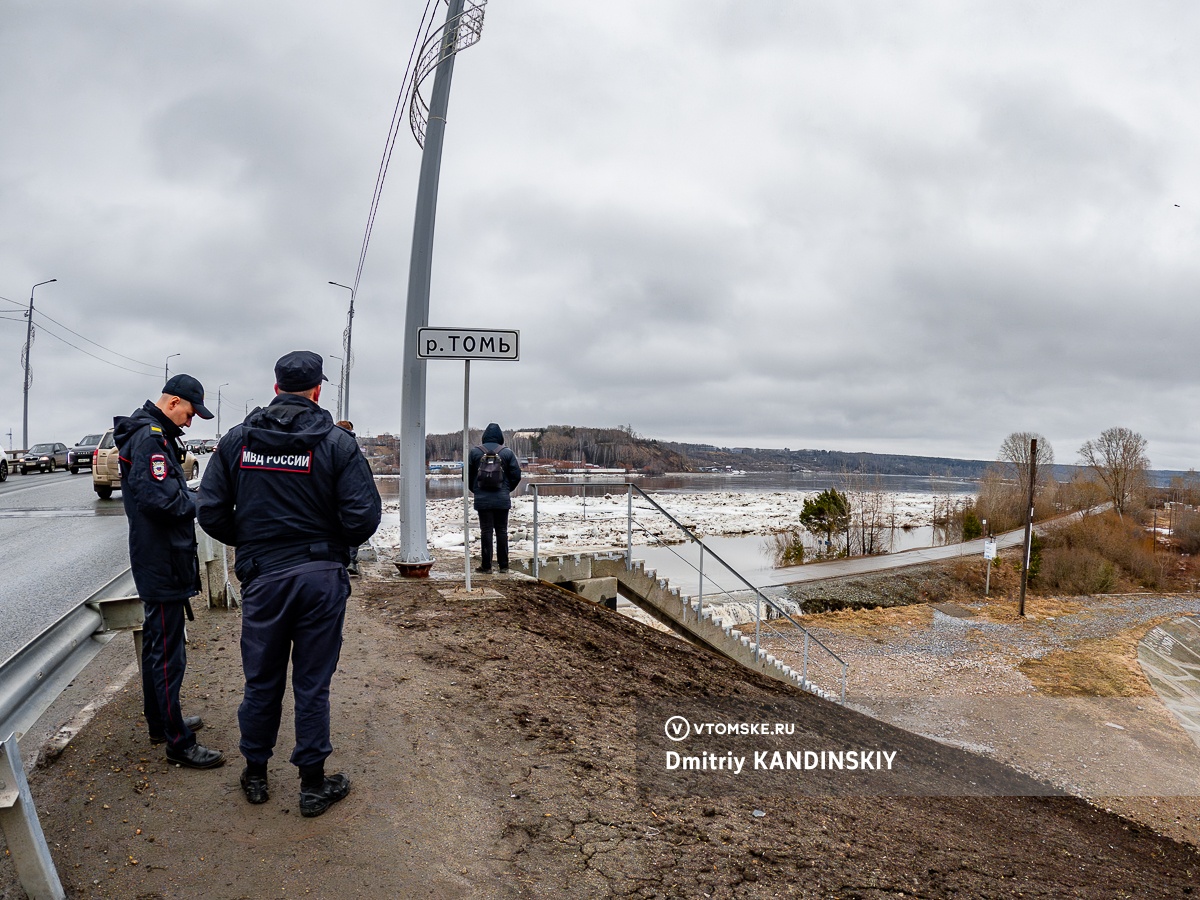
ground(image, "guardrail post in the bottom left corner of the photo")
xmin=0 ymin=734 xmax=66 ymax=900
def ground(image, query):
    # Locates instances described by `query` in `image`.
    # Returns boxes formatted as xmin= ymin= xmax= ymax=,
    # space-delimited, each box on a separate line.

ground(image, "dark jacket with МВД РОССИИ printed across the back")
xmin=198 ymin=394 xmax=382 ymax=582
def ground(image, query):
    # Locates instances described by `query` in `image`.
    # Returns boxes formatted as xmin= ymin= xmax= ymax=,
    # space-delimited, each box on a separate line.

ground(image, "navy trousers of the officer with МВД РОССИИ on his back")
xmin=238 ymin=560 xmax=350 ymax=766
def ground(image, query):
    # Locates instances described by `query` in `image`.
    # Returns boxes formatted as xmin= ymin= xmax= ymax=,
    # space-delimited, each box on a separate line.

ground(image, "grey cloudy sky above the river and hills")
xmin=0 ymin=0 xmax=1200 ymax=468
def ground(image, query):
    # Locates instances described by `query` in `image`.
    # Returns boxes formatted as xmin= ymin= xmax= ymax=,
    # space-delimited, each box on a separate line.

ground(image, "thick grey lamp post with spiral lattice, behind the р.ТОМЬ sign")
xmin=396 ymin=0 xmax=486 ymax=577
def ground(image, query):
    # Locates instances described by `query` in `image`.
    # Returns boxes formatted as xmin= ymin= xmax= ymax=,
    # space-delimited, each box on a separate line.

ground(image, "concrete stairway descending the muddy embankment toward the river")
xmin=510 ymin=552 xmax=839 ymax=702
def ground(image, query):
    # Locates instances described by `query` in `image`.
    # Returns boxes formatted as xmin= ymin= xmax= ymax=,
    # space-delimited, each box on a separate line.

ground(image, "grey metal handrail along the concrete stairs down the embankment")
xmin=529 ymin=481 xmax=850 ymax=703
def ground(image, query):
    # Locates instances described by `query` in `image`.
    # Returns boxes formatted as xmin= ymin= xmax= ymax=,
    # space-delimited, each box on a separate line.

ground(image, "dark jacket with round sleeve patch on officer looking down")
xmin=113 ymin=401 xmax=200 ymax=600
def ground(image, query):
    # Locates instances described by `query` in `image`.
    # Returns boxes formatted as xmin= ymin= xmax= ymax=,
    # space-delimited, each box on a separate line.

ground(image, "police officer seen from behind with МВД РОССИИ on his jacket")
xmin=199 ymin=350 xmax=382 ymax=818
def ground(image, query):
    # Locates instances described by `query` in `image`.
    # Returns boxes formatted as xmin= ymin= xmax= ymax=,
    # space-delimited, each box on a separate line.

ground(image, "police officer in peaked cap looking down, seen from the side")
xmin=113 ymin=374 xmax=224 ymax=769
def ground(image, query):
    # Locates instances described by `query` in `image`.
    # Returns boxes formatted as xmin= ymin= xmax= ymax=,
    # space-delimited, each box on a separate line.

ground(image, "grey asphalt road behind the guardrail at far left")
xmin=0 ymin=457 xmax=143 ymax=660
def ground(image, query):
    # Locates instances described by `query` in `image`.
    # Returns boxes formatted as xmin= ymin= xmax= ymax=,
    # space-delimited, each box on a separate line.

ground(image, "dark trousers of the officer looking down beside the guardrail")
xmin=142 ymin=600 xmax=196 ymax=750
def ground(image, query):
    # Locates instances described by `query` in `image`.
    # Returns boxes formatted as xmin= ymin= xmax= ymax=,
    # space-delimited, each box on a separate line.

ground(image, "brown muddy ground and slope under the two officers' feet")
xmin=0 ymin=569 xmax=1200 ymax=900
